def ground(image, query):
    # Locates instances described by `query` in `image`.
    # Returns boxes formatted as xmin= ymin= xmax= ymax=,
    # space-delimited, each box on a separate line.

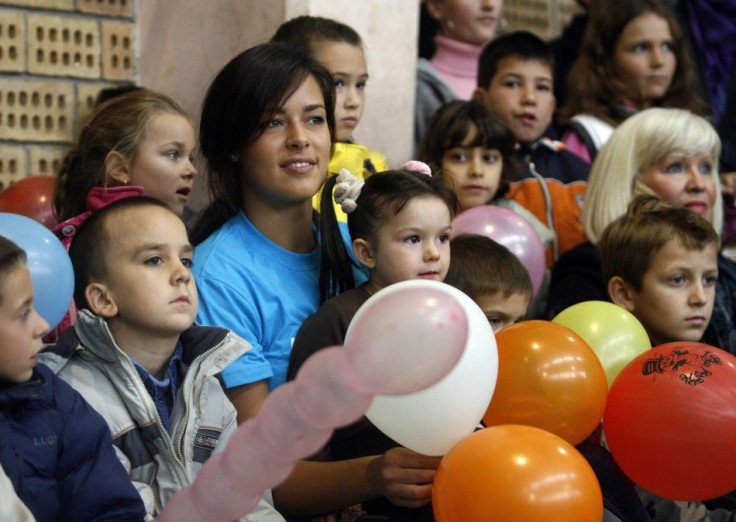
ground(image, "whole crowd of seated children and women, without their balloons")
xmin=0 ymin=0 xmax=736 ymax=522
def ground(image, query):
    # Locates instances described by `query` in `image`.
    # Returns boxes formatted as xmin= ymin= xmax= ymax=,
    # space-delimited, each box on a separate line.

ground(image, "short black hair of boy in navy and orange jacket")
xmin=478 ymin=31 xmax=555 ymax=89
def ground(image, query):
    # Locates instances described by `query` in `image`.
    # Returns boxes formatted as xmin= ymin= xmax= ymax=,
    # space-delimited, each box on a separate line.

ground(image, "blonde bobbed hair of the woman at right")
xmin=582 ymin=107 xmax=723 ymax=243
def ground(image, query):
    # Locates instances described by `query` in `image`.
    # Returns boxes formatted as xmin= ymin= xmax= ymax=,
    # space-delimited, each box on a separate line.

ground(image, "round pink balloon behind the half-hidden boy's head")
xmin=451 ymin=205 xmax=547 ymax=294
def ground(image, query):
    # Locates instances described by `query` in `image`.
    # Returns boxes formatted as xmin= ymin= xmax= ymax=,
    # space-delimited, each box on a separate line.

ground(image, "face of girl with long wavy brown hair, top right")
xmin=614 ymin=12 xmax=677 ymax=109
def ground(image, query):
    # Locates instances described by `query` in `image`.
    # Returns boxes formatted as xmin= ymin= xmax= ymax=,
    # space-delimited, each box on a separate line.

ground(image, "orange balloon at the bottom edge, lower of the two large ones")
xmin=432 ymin=425 xmax=603 ymax=522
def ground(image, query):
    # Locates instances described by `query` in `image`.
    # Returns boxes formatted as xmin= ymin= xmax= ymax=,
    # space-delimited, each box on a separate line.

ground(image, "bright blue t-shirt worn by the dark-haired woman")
xmin=193 ymin=211 xmax=365 ymax=390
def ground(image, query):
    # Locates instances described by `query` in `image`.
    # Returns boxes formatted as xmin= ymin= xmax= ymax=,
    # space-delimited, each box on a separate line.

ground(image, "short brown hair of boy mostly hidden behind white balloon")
xmin=445 ymin=234 xmax=534 ymax=300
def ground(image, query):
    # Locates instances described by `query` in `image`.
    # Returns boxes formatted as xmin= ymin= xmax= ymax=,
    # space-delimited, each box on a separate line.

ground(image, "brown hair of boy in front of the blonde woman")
xmin=597 ymin=195 xmax=720 ymax=291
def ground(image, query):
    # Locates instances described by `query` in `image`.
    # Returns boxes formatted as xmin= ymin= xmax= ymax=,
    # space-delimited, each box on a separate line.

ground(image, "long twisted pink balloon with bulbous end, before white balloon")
xmin=158 ymin=281 xmax=468 ymax=522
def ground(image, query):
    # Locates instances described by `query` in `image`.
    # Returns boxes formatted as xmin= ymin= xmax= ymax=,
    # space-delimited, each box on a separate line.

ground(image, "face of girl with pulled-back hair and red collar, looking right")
xmin=127 ymin=113 xmax=197 ymax=215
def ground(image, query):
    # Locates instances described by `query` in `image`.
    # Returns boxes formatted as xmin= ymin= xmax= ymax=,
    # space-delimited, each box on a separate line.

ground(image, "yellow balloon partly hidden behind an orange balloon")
xmin=552 ymin=301 xmax=652 ymax=388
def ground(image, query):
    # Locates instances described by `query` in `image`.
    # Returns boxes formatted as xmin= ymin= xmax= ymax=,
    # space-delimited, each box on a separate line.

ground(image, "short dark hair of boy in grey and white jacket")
xmin=69 ymin=196 xmax=173 ymax=310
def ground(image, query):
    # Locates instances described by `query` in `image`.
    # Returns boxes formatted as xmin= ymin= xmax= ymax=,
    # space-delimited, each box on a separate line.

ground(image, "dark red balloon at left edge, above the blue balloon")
xmin=0 ymin=176 xmax=58 ymax=228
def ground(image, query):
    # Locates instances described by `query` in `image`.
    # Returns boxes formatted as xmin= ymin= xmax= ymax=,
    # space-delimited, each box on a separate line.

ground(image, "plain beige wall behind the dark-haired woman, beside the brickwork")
xmin=136 ymin=0 xmax=419 ymax=208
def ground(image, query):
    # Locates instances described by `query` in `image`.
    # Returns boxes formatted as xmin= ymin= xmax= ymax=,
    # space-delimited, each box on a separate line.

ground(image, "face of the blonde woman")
xmin=639 ymin=151 xmax=718 ymax=223
